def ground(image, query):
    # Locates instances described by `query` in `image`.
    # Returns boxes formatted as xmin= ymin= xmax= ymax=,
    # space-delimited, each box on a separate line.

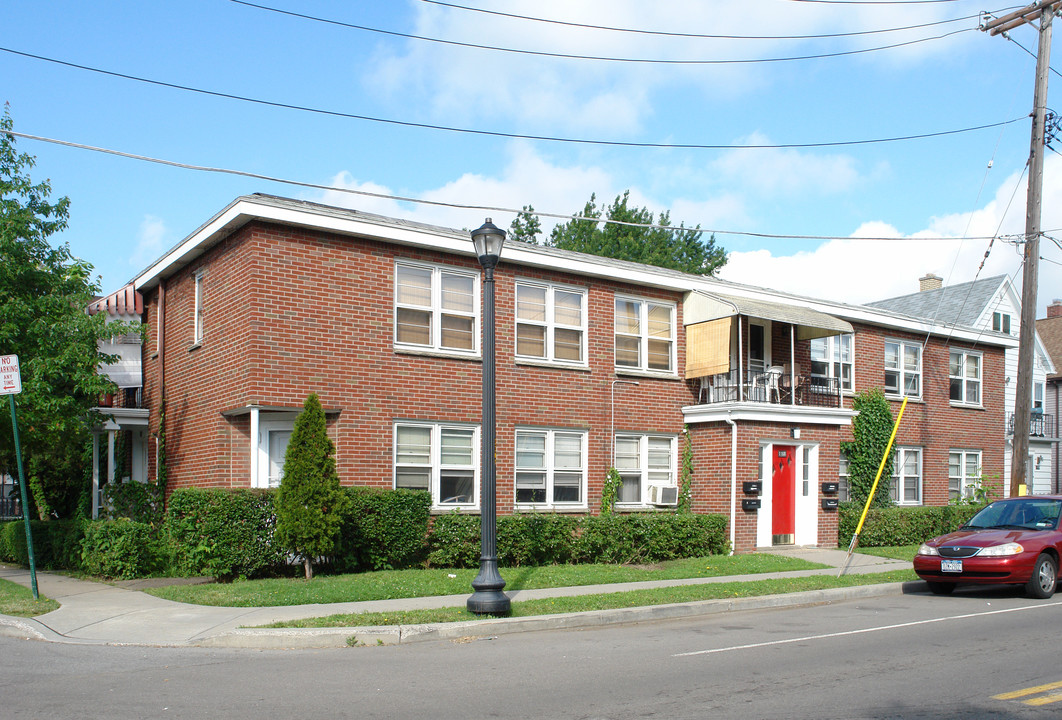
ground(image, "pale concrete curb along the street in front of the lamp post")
xmin=193 ymin=581 xmax=925 ymax=650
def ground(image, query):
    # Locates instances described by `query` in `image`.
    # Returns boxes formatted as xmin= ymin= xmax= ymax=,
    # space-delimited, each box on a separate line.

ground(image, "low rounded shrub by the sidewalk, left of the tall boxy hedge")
xmin=81 ymin=518 xmax=159 ymax=580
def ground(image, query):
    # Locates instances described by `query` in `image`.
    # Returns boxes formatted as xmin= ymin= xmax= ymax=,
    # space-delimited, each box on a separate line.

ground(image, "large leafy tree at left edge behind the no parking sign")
xmin=0 ymin=107 xmax=121 ymax=519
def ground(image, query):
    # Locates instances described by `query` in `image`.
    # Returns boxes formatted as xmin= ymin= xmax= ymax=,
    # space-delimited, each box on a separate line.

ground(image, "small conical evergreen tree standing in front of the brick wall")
xmin=275 ymin=393 xmax=348 ymax=580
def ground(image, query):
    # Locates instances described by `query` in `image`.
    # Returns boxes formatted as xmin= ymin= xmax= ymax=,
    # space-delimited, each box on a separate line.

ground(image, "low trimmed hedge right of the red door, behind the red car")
xmin=837 ymin=502 xmax=983 ymax=548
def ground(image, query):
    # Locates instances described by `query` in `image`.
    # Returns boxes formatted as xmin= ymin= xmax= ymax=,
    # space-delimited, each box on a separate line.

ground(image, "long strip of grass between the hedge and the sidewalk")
xmin=144 ymin=553 xmax=827 ymax=612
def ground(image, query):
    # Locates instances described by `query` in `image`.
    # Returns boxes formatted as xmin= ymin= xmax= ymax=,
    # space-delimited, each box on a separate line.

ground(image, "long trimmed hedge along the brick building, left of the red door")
xmin=0 ymin=487 xmax=729 ymax=580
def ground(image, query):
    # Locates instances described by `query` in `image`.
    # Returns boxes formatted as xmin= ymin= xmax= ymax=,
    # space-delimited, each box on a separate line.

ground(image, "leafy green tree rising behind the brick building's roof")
xmin=543 ymin=190 xmax=726 ymax=275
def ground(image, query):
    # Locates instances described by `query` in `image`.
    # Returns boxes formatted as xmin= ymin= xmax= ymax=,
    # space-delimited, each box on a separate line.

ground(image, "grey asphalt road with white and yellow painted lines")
xmin=0 ymin=589 xmax=1062 ymax=720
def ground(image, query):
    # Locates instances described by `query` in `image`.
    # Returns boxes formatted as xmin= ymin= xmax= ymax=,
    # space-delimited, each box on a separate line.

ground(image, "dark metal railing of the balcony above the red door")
xmin=699 ymin=368 xmax=841 ymax=408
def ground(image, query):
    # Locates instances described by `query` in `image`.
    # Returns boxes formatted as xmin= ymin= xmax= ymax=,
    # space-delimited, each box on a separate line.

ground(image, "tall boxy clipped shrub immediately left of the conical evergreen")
xmin=166 ymin=490 xmax=284 ymax=580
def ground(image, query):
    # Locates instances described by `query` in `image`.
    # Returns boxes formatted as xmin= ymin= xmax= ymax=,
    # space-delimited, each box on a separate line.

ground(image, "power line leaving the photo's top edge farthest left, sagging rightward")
xmin=229 ymin=0 xmax=977 ymax=65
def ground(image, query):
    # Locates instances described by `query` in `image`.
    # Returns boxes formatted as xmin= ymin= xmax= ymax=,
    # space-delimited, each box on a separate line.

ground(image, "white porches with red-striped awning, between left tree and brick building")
xmin=88 ymin=285 xmax=148 ymax=517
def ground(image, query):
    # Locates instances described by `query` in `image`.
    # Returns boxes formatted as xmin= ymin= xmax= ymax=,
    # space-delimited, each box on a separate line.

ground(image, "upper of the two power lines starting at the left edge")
xmin=0 ymin=47 xmax=1026 ymax=150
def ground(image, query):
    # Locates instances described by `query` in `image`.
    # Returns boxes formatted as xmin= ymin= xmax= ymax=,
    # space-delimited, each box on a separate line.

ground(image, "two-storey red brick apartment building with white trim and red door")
xmin=105 ymin=195 xmax=1016 ymax=551
